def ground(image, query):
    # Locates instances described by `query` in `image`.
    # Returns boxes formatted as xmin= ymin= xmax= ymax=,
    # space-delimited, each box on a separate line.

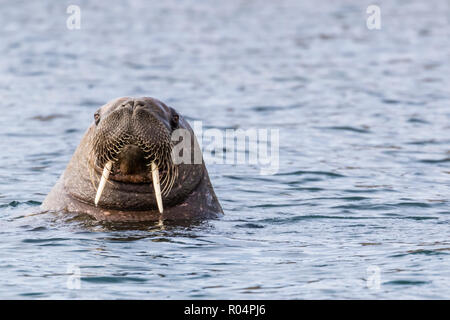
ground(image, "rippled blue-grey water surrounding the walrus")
xmin=0 ymin=0 xmax=450 ymax=299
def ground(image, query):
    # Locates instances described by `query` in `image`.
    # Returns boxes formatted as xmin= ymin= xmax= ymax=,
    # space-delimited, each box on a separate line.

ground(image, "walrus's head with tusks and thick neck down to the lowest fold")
xmin=61 ymin=97 xmax=207 ymax=213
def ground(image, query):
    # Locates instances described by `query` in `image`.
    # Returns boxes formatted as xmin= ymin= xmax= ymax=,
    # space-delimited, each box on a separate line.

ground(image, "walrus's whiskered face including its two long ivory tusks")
xmin=89 ymin=98 xmax=180 ymax=213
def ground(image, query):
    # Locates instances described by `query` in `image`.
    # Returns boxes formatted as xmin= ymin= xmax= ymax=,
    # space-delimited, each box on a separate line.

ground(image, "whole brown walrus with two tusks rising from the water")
xmin=42 ymin=97 xmax=223 ymax=222
